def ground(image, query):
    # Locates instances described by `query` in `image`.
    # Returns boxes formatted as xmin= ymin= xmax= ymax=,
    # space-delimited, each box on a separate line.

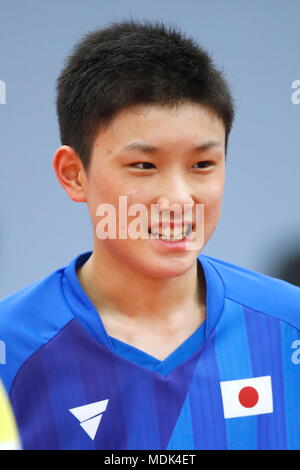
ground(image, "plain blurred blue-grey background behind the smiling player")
xmin=0 ymin=0 xmax=300 ymax=298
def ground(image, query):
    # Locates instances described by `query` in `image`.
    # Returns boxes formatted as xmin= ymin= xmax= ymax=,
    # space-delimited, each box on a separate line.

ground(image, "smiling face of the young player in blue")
xmin=85 ymin=103 xmax=225 ymax=278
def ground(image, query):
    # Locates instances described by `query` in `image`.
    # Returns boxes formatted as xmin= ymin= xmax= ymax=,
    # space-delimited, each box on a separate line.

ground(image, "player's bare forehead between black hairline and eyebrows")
xmin=95 ymin=103 xmax=225 ymax=148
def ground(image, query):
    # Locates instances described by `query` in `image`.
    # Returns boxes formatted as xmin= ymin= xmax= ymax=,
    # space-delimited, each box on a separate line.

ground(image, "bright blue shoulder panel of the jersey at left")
xmin=0 ymin=268 xmax=73 ymax=391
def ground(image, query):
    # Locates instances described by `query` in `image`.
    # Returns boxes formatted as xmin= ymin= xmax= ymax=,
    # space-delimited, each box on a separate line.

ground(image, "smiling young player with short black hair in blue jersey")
xmin=0 ymin=20 xmax=300 ymax=450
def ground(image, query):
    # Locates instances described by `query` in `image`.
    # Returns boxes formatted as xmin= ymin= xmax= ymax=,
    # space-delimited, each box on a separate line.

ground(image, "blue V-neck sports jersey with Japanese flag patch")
xmin=0 ymin=252 xmax=300 ymax=450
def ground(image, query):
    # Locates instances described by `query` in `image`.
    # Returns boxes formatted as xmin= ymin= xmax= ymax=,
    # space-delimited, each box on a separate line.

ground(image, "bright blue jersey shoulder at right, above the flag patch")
xmin=200 ymin=255 xmax=300 ymax=329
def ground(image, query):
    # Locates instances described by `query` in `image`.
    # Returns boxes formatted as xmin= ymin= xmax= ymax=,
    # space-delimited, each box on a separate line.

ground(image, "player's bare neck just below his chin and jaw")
xmin=77 ymin=244 xmax=205 ymax=324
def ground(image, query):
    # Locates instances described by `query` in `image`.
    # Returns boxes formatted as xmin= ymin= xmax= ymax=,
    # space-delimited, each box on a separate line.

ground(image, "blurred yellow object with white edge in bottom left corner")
xmin=0 ymin=383 xmax=21 ymax=450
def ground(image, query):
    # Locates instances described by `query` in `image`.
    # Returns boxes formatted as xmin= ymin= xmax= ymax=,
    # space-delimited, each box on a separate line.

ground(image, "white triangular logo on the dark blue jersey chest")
xmin=69 ymin=400 xmax=108 ymax=440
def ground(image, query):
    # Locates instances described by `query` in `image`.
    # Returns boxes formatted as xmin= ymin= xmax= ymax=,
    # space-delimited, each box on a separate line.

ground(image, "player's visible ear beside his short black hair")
xmin=52 ymin=145 xmax=87 ymax=202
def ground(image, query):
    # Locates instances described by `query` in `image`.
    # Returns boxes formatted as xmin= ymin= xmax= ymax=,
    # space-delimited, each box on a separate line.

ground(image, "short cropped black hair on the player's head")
xmin=56 ymin=18 xmax=235 ymax=170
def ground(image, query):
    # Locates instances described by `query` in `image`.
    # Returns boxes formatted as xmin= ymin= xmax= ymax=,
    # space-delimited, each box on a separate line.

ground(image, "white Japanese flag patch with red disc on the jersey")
xmin=220 ymin=375 xmax=273 ymax=418
